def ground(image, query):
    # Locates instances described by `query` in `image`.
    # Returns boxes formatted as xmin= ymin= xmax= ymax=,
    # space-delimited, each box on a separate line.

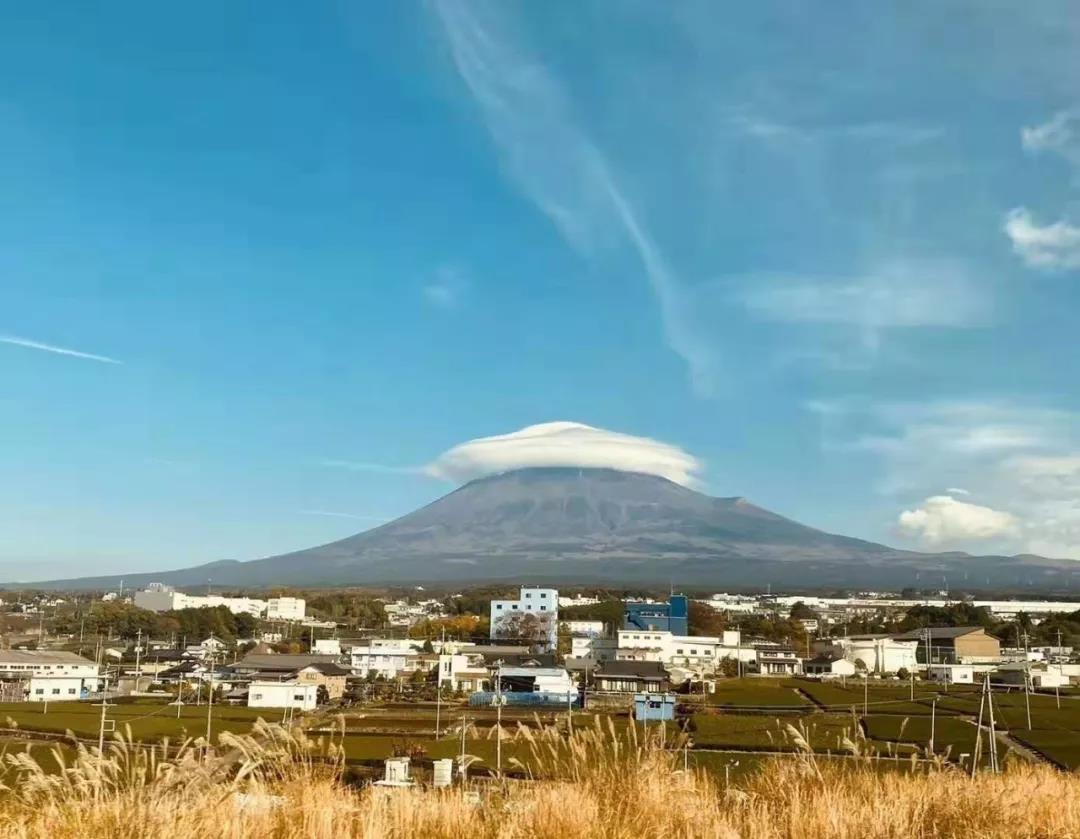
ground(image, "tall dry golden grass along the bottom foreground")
xmin=0 ymin=712 xmax=1080 ymax=839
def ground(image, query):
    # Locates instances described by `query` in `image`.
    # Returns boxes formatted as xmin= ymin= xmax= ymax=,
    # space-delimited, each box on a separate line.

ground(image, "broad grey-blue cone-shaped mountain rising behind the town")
xmin=14 ymin=468 xmax=1080 ymax=591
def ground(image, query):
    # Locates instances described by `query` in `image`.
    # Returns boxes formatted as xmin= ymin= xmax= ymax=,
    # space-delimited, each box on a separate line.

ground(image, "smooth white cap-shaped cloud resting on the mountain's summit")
xmin=426 ymin=422 xmax=702 ymax=486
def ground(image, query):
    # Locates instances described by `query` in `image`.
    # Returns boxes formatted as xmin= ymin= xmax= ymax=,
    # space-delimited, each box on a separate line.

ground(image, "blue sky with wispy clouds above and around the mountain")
xmin=0 ymin=0 xmax=1080 ymax=579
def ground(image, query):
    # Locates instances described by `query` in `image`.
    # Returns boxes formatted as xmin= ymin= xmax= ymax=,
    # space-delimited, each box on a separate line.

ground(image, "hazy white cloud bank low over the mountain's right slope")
xmin=809 ymin=400 xmax=1080 ymax=559
